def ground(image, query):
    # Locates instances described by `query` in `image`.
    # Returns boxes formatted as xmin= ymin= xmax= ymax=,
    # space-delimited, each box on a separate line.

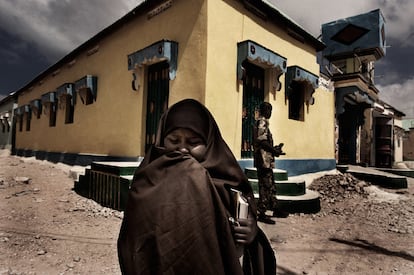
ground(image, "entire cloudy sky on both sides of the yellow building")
xmin=0 ymin=0 xmax=414 ymax=118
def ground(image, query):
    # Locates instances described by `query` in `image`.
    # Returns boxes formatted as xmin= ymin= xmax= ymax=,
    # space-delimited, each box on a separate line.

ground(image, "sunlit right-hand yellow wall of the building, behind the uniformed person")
xmin=206 ymin=1 xmax=335 ymax=159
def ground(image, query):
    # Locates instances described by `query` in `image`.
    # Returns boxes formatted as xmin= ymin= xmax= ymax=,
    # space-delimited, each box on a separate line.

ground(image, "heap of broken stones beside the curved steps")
xmin=309 ymin=173 xmax=370 ymax=203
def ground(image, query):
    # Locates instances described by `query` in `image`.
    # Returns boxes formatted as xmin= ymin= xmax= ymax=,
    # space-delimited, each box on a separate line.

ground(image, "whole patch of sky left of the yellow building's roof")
xmin=0 ymin=0 xmax=141 ymax=95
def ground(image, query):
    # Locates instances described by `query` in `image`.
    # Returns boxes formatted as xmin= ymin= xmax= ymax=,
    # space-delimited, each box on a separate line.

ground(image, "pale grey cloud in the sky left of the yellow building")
xmin=0 ymin=0 xmax=136 ymax=61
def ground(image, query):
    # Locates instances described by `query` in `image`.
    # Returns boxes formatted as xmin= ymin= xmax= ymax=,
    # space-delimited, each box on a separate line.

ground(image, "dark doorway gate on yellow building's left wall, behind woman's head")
xmin=145 ymin=62 xmax=169 ymax=151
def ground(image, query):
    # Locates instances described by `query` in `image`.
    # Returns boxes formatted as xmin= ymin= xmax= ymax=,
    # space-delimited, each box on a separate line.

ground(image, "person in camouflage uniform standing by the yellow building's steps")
xmin=253 ymin=102 xmax=287 ymax=224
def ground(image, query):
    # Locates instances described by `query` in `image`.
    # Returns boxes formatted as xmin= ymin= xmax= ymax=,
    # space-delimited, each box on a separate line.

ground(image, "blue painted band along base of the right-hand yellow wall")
xmin=238 ymin=159 xmax=336 ymax=176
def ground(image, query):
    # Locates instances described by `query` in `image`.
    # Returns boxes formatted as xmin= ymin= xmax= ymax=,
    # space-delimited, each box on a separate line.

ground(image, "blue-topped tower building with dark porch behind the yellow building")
xmin=320 ymin=9 xmax=405 ymax=168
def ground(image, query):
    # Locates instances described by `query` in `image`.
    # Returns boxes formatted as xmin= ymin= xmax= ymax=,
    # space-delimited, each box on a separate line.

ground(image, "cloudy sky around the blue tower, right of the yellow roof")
xmin=272 ymin=0 xmax=414 ymax=118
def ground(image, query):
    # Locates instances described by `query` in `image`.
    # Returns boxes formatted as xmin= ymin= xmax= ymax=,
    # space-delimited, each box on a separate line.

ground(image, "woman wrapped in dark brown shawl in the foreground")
xmin=118 ymin=99 xmax=276 ymax=275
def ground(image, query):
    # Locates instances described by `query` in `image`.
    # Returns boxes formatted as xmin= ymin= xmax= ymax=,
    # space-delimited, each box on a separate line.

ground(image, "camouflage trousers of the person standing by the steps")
xmin=257 ymin=168 xmax=277 ymax=214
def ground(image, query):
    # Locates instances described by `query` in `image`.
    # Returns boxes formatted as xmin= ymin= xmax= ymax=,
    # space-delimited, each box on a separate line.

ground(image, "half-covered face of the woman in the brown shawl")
xmin=164 ymin=128 xmax=207 ymax=162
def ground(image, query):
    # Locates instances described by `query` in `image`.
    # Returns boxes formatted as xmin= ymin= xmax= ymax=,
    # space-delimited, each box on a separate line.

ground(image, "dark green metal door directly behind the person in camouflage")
xmin=241 ymin=61 xmax=264 ymax=158
